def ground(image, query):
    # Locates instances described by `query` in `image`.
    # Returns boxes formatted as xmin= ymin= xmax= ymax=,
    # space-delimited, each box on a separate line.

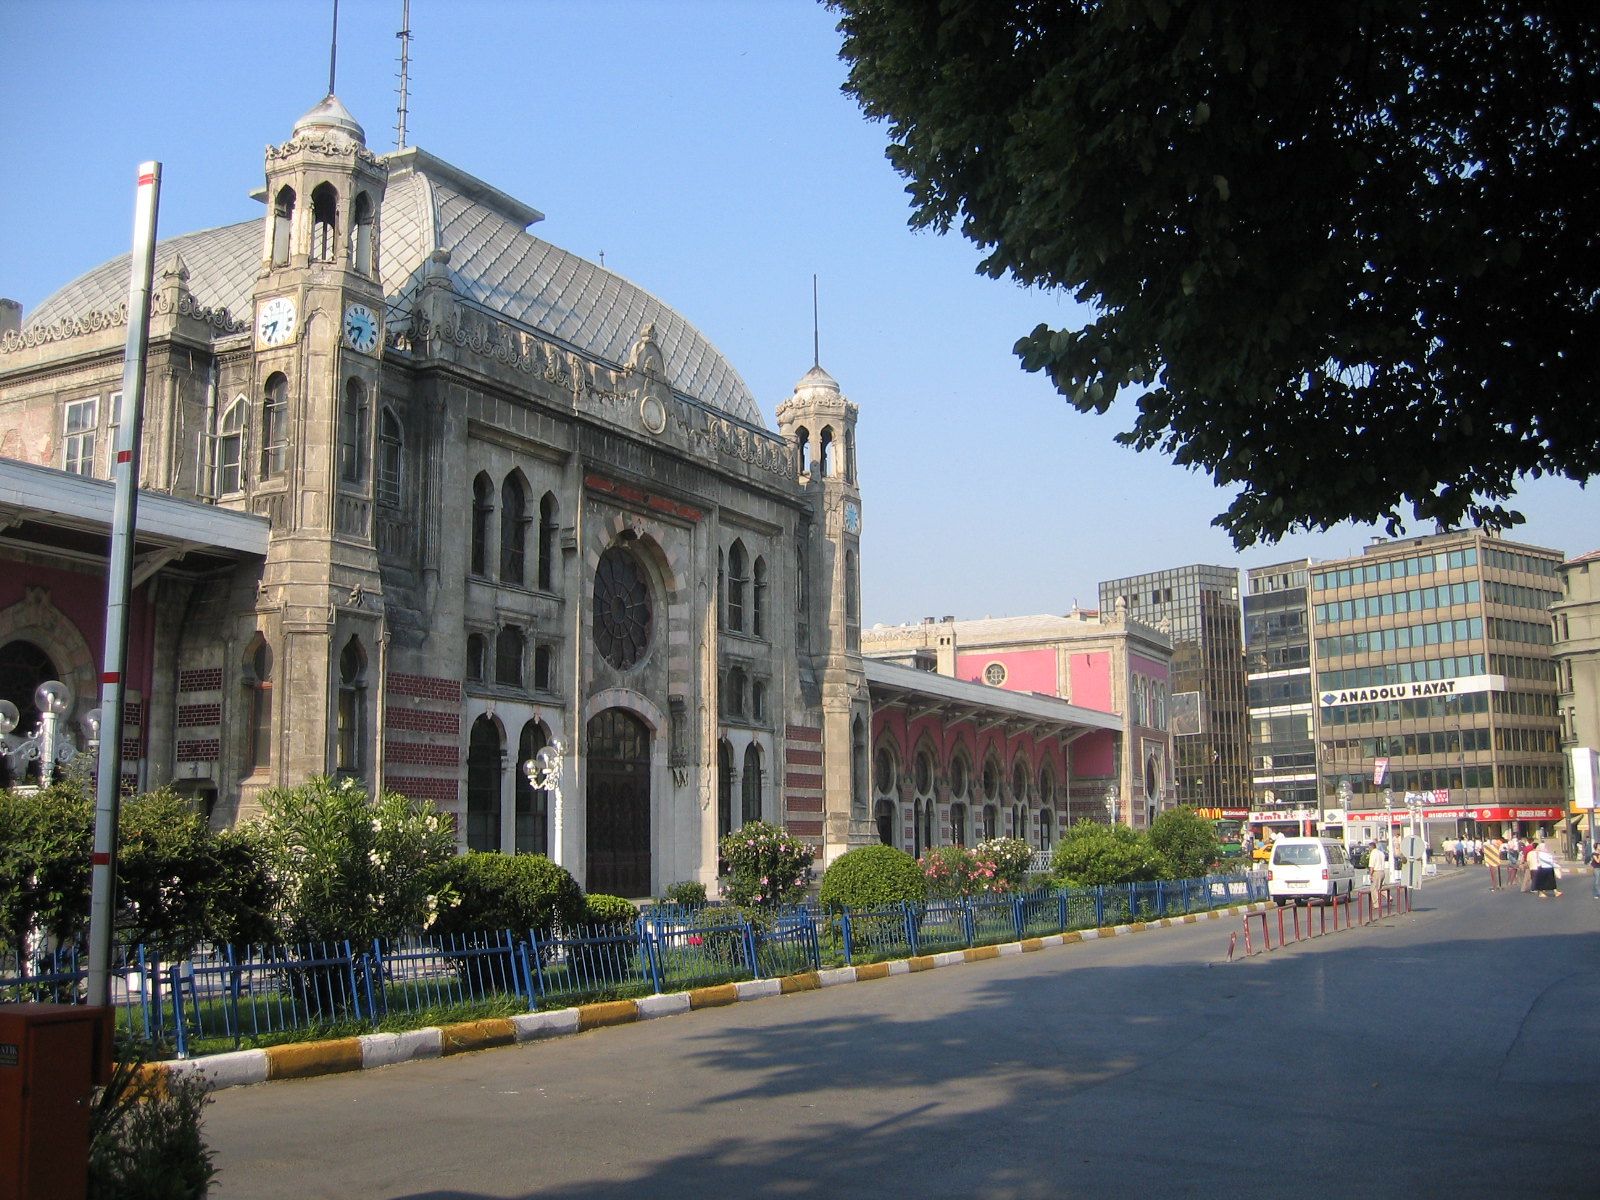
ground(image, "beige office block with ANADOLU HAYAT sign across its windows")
xmin=1310 ymin=530 xmax=1565 ymax=840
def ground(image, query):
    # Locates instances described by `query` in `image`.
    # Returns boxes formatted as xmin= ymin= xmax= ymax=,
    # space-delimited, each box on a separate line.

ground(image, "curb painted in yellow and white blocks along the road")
xmin=146 ymin=904 xmax=1272 ymax=1090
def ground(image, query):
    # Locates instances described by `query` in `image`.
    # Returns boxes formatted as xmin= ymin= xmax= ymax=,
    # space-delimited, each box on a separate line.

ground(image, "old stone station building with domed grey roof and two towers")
xmin=0 ymin=96 xmax=1120 ymax=896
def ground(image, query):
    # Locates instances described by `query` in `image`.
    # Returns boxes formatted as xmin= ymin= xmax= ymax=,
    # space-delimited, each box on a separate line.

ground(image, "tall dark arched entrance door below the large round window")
xmin=584 ymin=709 xmax=650 ymax=898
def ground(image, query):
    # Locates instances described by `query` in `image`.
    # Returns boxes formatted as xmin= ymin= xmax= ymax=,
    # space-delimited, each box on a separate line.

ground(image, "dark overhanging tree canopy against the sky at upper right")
xmin=829 ymin=0 xmax=1600 ymax=547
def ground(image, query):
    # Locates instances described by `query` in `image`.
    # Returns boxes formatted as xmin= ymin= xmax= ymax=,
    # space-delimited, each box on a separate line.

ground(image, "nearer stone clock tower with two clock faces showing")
xmin=242 ymin=94 xmax=387 ymax=811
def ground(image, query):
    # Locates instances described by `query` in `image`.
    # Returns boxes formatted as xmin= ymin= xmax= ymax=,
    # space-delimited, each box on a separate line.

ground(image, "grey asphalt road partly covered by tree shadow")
xmin=206 ymin=869 xmax=1600 ymax=1200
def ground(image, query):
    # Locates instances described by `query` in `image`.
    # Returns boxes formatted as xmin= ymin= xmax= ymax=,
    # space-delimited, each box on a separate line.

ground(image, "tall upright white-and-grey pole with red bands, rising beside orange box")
xmin=88 ymin=163 xmax=162 ymax=1005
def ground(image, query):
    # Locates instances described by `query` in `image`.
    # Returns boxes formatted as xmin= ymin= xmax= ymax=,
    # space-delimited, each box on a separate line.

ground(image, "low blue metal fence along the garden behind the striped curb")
xmin=0 ymin=874 xmax=1266 ymax=1056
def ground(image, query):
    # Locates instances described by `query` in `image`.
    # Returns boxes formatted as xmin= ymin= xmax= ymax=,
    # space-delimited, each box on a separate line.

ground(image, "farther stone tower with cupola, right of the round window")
xmin=778 ymin=366 xmax=877 ymax=861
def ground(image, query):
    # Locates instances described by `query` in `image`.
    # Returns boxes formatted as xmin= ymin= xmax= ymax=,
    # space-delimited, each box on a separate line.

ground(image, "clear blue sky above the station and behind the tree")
xmin=0 ymin=0 xmax=1600 ymax=624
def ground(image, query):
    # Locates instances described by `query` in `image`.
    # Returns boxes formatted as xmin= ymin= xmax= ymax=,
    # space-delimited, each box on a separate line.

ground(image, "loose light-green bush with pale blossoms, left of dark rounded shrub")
xmin=261 ymin=776 xmax=456 ymax=942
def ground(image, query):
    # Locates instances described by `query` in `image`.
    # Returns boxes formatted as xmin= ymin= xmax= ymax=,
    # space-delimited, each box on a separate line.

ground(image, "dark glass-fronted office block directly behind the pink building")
xmin=1099 ymin=565 xmax=1250 ymax=808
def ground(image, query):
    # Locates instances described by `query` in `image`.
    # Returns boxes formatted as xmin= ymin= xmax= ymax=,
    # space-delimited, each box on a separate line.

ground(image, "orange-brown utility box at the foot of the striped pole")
xmin=0 ymin=1003 xmax=114 ymax=1200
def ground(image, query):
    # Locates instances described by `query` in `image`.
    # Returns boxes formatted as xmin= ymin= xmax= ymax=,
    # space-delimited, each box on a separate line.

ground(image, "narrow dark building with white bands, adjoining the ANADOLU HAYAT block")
xmin=1245 ymin=558 xmax=1318 ymax=819
